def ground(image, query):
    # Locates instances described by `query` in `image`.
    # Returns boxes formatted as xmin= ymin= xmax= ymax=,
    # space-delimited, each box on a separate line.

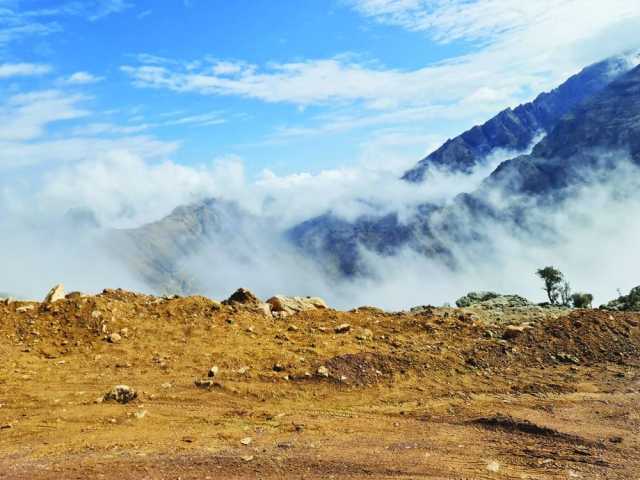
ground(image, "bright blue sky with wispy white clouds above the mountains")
xmin=0 ymin=0 xmax=640 ymax=225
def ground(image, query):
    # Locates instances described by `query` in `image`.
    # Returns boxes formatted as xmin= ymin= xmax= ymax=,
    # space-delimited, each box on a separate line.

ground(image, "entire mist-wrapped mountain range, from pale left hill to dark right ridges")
xmin=110 ymin=51 xmax=640 ymax=293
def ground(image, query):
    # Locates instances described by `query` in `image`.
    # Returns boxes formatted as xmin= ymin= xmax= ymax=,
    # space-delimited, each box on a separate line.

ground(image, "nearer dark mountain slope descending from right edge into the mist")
xmin=289 ymin=62 xmax=640 ymax=275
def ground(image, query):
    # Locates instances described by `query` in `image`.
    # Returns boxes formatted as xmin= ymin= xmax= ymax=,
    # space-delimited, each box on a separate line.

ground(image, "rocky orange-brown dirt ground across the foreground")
xmin=0 ymin=291 xmax=640 ymax=480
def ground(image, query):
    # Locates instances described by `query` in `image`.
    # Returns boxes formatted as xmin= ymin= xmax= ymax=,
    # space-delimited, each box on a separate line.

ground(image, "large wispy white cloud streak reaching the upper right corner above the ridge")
xmin=122 ymin=0 xmax=640 ymax=145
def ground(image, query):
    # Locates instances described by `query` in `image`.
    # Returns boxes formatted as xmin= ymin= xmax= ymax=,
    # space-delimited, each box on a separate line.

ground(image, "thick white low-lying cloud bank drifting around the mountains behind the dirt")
xmin=0 ymin=142 xmax=640 ymax=309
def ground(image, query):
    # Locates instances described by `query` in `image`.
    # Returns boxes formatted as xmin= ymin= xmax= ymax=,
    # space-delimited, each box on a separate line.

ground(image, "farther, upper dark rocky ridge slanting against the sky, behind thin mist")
xmin=402 ymin=57 xmax=633 ymax=182
